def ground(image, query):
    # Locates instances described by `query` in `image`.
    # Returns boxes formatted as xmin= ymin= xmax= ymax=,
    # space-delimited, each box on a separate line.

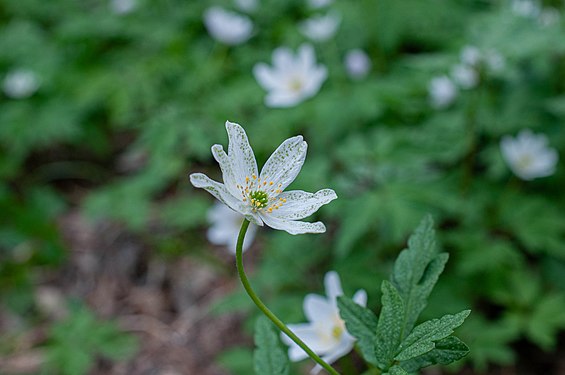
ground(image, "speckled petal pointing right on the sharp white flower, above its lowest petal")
xmin=270 ymin=189 xmax=337 ymax=220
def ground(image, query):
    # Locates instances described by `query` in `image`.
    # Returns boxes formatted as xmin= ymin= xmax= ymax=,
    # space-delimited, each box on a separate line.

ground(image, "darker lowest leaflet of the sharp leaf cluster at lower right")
xmin=401 ymin=336 xmax=469 ymax=372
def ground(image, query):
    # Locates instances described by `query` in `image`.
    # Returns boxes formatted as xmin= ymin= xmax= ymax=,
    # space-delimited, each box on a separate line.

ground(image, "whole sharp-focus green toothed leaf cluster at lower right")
xmin=338 ymin=216 xmax=470 ymax=374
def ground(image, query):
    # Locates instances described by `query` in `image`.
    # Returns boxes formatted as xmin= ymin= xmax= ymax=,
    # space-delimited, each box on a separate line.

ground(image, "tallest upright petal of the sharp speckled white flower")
xmin=226 ymin=121 xmax=257 ymax=185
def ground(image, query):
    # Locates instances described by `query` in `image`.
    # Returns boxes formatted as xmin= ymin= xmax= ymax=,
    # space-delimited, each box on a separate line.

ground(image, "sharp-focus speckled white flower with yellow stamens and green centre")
xmin=190 ymin=121 xmax=337 ymax=234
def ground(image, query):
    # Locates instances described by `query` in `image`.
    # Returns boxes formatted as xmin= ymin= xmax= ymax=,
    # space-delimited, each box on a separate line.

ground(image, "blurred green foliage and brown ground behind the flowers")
xmin=0 ymin=0 xmax=565 ymax=375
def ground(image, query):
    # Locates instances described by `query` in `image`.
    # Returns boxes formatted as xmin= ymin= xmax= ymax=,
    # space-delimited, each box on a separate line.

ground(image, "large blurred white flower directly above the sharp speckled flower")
xmin=253 ymin=44 xmax=328 ymax=107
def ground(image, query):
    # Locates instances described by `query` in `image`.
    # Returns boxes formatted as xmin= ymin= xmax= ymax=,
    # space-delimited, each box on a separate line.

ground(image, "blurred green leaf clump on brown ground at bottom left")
xmin=45 ymin=305 xmax=138 ymax=375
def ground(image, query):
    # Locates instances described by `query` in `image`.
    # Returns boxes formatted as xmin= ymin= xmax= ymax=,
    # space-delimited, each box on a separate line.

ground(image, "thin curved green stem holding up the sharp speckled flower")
xmin=235 ymin=220 xmax=339 ymax=375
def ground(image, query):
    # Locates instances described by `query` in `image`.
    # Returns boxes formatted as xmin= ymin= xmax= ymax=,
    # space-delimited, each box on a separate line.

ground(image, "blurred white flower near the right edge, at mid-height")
xmin=500 ymin=130 xmax=558 ymax=180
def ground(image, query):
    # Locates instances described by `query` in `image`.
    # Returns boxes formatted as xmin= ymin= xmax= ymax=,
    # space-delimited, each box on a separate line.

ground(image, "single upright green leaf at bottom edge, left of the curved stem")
xmin=254 ymin=317 xmax=289 ymax=375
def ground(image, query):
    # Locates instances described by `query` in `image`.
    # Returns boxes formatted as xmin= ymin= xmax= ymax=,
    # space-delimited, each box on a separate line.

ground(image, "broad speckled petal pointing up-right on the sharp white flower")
xmin=261 ymin=135 xmax=308 ymax=190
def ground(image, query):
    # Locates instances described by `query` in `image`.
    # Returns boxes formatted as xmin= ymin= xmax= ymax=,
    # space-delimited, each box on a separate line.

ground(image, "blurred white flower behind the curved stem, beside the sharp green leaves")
xmin=281 ymin=271 xmax=367 ymax=373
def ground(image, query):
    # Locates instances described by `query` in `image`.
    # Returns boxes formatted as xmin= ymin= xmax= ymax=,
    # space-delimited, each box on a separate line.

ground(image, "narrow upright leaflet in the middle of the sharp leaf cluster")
xmin=375 ymin=280 xmax=404 ymax=369
